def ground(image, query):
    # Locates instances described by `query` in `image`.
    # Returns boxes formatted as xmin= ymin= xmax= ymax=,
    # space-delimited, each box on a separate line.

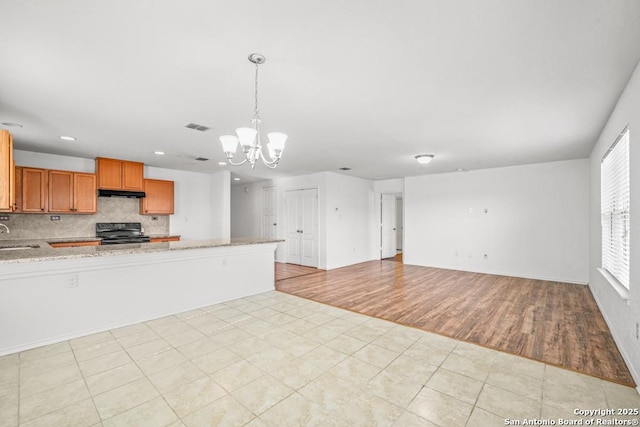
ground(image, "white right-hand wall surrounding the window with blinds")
xmin=589 ymin=57 xmax=640 ymax=390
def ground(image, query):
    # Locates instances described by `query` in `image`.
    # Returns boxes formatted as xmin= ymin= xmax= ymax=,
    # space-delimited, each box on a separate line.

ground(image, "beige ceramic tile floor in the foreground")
xmin=0 ymin=291 xmax=640 ymax=427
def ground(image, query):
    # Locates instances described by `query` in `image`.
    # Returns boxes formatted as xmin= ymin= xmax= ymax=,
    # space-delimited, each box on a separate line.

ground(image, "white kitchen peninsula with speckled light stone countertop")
xmin=0 ymin=238 xmax=278 ymax=355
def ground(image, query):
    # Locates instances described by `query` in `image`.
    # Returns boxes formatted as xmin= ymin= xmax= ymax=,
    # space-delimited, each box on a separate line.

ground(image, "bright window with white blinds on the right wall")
xmin=600 ymin=127 xmax=631 ymax=290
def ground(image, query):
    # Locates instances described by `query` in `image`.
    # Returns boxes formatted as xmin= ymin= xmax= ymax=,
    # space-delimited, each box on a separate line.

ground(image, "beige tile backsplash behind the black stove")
xmin=0 ymin=197 xmax=169 ymax=240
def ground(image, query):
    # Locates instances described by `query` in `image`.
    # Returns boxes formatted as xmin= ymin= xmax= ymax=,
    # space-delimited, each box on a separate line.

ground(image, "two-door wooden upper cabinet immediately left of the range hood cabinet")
xmin=49 ymin=170 xmax=97 ymax=213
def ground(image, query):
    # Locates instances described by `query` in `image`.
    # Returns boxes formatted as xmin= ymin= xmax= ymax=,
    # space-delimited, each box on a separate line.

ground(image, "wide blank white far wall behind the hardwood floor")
xmin=404 ymin=159 xmax=589 ymax=284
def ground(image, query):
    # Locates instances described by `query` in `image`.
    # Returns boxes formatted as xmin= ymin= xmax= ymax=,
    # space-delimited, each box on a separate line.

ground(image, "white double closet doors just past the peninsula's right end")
xmin=285 ymin=188 xmax=318 ymax=267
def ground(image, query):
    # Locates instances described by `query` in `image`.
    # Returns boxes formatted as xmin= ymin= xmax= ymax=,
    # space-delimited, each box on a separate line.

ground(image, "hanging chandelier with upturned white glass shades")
xmin=220 ymin=53 xmax=287 ymax=169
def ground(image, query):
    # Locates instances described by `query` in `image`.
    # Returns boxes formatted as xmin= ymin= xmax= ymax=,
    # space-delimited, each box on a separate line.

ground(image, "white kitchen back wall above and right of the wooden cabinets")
xmin=14 ymin=150 xmax=231 ymax=240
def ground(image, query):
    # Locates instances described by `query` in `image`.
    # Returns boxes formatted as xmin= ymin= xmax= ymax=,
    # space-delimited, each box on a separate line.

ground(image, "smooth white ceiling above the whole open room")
xmin=0 ymin=0 xmax=640 ymax=182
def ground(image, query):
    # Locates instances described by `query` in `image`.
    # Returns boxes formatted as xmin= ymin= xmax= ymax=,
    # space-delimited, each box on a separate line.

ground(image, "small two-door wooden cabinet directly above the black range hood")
xmin=96 ymin=157 xmax=144 ymax=191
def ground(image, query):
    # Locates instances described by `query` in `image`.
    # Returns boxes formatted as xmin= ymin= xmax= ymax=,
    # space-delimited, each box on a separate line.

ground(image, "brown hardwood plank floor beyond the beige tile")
xmin=276 ymin=260 xmax=635 ymax=386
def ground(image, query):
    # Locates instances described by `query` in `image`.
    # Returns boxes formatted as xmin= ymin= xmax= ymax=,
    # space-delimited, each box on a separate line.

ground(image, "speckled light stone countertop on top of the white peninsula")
xmin=0 ymin=237 xmax=284 ymax=264
